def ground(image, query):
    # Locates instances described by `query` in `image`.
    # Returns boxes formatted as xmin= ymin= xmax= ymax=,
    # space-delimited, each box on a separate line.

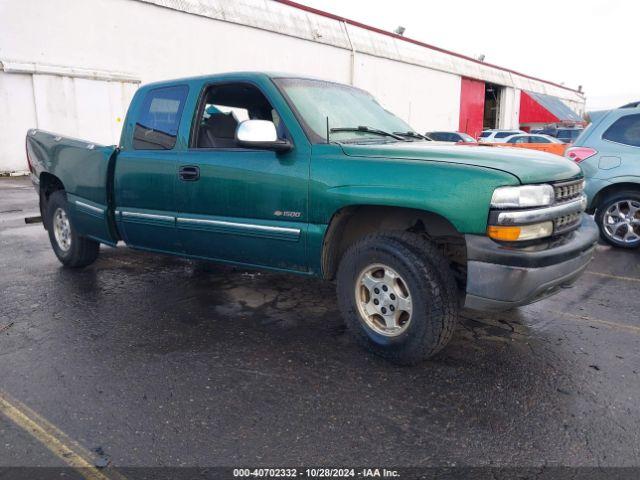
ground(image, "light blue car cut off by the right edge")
xmin=565 ymin=106 xmax=640 ymax=248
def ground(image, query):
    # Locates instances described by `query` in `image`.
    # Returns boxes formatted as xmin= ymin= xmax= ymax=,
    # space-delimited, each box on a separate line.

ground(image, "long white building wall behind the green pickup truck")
xmin=0 ymin=0 xmax=584 ymax=172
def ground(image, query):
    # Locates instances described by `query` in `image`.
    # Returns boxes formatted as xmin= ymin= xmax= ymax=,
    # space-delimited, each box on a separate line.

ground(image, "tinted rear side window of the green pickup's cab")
xmin=133 ymin=85 xmax=189 ymax=150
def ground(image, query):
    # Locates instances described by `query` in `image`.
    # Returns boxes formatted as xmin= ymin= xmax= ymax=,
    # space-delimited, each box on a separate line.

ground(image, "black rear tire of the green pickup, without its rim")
xmin=45 ymin=190 xmax=100 ymax=268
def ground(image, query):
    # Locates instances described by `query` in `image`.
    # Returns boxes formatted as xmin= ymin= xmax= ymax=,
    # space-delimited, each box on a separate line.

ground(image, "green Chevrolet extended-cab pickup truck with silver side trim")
xmin=26 ymin=73 xmax=598 ymax=363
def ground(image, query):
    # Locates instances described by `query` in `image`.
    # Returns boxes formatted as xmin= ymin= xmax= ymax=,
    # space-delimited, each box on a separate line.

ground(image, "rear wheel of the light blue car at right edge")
xmin=596 ymin=191 xmax=640 ymax=248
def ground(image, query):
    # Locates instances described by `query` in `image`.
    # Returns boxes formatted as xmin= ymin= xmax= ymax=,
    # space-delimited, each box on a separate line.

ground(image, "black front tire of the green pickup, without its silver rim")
xmin=337 ymin=232 xmax=459 ymax=365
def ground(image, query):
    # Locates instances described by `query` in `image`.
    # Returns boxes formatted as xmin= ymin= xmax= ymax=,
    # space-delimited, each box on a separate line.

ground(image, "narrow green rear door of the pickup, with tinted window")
xmin=114 ymin=85 xmax=189 ymax=253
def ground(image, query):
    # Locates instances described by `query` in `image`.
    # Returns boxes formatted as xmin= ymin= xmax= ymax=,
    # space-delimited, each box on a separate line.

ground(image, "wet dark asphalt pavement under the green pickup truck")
xmin=0 ymin=178 xmax=640 ymax=466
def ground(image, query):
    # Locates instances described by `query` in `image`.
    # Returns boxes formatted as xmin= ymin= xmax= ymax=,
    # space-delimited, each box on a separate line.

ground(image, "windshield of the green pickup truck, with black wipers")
xmin=274 ymin=78 xmax=413 ymax=143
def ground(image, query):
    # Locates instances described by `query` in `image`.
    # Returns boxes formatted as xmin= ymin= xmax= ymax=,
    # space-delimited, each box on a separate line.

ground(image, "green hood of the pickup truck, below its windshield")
xmin=341 ymin=142 xmax=581 ymax=184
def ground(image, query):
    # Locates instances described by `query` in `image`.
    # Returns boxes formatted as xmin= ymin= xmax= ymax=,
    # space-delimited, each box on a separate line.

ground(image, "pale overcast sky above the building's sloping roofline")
xmin=297 ymin=0 xmax=640 ymax=110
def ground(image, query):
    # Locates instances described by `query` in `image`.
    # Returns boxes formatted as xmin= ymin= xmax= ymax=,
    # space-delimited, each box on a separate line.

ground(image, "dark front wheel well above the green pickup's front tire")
xmin=322 ymin=205 xmax=467 ymax=284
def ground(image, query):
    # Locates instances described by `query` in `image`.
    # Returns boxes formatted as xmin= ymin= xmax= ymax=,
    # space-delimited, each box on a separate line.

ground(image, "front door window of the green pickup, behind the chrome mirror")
xmin=191 ymin=83 xmax=287 ymax=149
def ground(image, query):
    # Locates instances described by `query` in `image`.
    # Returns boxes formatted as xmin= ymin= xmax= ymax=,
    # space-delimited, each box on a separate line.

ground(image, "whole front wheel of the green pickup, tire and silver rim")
xmin=337 ymin=232 xmax=459 ymax=365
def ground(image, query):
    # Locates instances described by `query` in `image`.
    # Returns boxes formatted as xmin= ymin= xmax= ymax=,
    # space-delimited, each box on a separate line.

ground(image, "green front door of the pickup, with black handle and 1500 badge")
xmin=171 ymin=82 xmax=309 ymax=271
